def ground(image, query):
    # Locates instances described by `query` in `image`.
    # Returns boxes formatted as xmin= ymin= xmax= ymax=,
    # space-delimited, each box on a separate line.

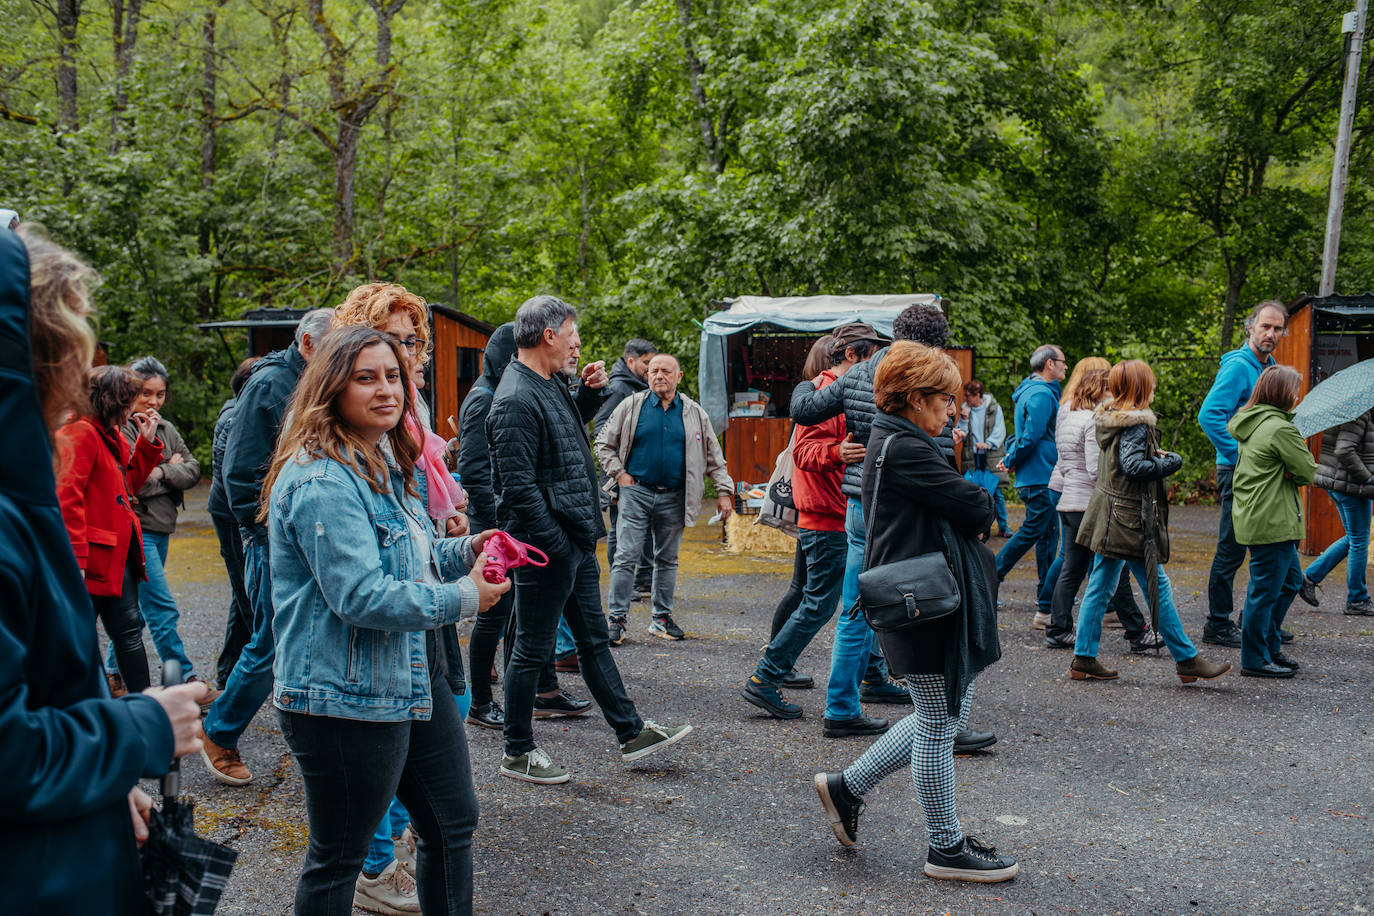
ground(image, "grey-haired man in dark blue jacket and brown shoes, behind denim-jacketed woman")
xmin=201 ymin=309 xmax=334 ymax=786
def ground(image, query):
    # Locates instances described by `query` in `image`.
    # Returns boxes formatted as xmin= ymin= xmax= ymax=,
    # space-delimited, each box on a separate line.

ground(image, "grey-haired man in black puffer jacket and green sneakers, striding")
xmin=486 ymin=295 xmax=691 ymax=783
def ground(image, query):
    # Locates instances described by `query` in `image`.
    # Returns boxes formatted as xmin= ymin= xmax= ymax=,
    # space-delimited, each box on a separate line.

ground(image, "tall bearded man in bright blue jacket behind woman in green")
xmin=1198 ymin=299 xmax=1287 ymax=648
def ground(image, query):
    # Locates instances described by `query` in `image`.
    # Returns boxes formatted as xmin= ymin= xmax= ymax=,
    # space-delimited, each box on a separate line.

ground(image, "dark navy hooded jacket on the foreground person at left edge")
xmin=0 ymin=228 xmax=172 ymax=916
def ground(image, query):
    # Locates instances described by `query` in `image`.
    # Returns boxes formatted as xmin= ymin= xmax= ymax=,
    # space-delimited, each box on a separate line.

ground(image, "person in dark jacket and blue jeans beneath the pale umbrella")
xmin=1298 ymin=411 xmax=1374 ymax=617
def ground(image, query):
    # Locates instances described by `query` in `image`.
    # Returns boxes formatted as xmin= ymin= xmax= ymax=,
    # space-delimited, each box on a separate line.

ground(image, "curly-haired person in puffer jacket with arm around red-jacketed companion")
xmin=791 ymin=304 xmax=998 ymax=753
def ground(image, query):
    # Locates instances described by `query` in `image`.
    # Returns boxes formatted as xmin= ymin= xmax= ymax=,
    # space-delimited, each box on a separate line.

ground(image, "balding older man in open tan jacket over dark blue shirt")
xmin=596 ymin=353 xmax=735 ymax=645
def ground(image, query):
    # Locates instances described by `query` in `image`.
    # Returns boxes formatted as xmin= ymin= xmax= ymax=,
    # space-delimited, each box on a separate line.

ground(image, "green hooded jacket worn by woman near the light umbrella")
xmin=1226 ymin=404 xmax=1316 ymax=544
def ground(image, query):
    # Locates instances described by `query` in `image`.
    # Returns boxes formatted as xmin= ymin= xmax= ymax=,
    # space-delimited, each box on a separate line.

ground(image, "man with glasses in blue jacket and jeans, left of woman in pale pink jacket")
xmin=998 ymin=343 xmax=1069 ymax=595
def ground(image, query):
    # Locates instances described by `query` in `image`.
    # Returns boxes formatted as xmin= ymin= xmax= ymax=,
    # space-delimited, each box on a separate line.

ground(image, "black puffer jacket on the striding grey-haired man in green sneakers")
xmin=486 ymin=360 xmax=606 ymax=559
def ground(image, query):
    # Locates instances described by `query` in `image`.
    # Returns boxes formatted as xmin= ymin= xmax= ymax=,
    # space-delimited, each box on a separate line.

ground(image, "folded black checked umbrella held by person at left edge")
xmin=142 ymin=662 xmax=239 ymax=916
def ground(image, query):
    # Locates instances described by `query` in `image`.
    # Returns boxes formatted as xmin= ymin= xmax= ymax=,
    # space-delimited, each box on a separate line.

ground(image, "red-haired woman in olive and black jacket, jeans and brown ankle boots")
xmin=1069 ymin=360 xmax=1231 ymax=684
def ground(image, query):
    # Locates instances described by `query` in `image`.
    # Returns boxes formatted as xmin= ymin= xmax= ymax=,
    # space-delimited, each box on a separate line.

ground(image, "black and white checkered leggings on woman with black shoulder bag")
xmin=845 ymin=674 xmax=973 ymax=849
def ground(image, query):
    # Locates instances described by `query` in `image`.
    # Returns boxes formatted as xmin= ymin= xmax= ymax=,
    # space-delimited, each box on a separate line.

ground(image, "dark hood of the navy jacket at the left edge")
xmin=0 ymin=228 xmax=58 ymax=505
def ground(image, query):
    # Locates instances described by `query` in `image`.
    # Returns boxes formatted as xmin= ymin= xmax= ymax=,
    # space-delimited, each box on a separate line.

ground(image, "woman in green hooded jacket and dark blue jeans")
xmin=1226 ymin=365 xmax=1316 ymax=677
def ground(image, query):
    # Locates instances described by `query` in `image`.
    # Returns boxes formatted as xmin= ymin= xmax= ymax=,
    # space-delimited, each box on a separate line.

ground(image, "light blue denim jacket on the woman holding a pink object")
xmin=268 ymin=456 xmax=478 ymax=722
